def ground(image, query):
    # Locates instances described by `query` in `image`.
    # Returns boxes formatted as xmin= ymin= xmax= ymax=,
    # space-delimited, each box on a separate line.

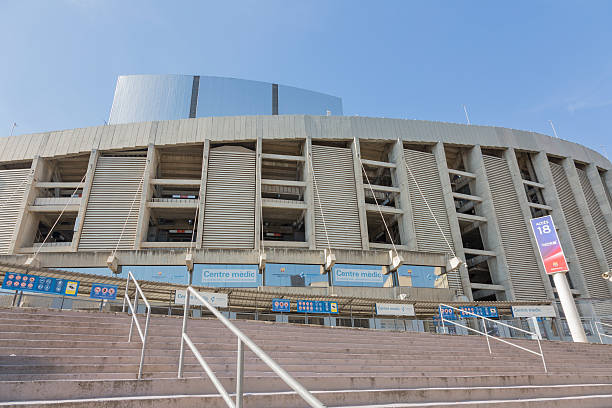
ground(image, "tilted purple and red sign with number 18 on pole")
xmin=531 ymin=215 xmax=569 ymax=274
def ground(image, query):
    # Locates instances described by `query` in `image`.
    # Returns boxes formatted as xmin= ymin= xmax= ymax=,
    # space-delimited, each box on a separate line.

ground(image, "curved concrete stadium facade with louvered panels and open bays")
xmin=0 ymin=115 xmax=612 ymax=315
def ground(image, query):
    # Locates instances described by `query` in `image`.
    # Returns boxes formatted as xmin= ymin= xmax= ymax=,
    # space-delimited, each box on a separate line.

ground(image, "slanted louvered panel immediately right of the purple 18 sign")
xmin=550 ymin=163 xmax=610 ymax=298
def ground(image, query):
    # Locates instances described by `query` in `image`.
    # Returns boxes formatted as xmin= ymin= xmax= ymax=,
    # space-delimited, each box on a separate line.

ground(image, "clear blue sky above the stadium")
xmin=0 ymin=0 xmax=612 ymax=157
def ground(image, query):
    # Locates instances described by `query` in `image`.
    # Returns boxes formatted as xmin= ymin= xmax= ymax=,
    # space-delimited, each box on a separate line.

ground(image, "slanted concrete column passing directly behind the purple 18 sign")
xmin=531 ymin=151 xmax=588 ymax=295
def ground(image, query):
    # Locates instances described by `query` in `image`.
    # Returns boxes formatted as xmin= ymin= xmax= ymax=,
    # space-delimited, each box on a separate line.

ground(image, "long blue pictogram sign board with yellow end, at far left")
xmin=2 ymin=272 xmax=80 ymax=296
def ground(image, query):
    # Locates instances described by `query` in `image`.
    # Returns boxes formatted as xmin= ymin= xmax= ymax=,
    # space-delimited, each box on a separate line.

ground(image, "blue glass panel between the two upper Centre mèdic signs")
xmin=265 ymin=263 xmax=329 ymax=287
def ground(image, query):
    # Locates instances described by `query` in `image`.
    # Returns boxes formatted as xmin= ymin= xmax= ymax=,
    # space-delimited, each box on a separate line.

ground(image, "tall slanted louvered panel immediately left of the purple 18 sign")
xmin=483 ymin=156 xmax=546 ymax=300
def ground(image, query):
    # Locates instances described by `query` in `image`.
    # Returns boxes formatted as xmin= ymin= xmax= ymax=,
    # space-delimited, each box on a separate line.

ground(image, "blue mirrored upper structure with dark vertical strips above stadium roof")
xmin=108 ymin=75 xmax=342 ymax=125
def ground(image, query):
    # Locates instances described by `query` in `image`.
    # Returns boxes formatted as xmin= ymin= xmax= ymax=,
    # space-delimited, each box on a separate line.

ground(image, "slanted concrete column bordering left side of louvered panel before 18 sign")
xmin=464 ymin=145 xmax=514 ymax=301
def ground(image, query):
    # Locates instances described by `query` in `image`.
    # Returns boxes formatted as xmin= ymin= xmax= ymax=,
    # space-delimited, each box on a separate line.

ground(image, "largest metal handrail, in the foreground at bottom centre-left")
xmin=178 ymin=286 xmax=325 ymax=408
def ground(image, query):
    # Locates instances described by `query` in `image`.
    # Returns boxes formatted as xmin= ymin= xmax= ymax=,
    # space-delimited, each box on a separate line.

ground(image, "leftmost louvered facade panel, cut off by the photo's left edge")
xmin=0 ymin=169 xmax=30 ymax=255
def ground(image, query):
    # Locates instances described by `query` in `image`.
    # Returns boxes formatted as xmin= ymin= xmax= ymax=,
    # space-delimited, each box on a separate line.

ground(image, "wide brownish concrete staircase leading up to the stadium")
xmin=0 ymin=309 xmax=612 ymax=408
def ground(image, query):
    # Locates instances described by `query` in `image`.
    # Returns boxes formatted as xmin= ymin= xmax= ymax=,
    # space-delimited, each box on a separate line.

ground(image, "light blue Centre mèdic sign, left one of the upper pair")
xmin=195 ymin=264 xmax=261 ymax=288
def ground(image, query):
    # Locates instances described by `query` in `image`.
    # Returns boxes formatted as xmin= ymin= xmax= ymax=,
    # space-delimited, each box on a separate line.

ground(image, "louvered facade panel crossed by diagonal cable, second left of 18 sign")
xmin=404 ymin=149 xmax=462 ymax=291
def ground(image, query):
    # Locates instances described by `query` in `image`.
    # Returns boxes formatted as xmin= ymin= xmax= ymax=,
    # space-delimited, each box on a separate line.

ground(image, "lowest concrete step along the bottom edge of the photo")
xmin=0 ymin=384 xmax=612 ymax=408
